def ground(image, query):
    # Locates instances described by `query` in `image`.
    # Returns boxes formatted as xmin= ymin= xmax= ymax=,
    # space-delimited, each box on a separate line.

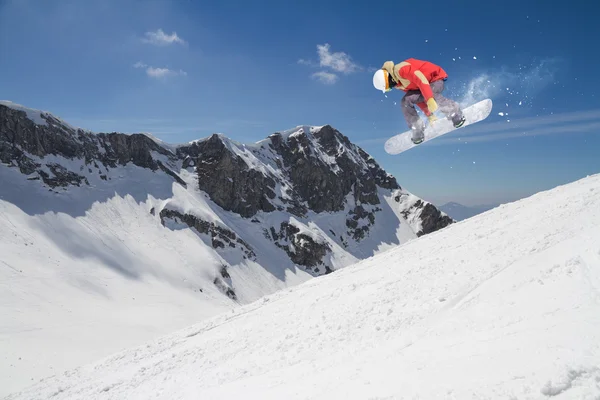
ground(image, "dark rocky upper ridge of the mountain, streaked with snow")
xmin=0 ymin=102 xmax=453 ymax=290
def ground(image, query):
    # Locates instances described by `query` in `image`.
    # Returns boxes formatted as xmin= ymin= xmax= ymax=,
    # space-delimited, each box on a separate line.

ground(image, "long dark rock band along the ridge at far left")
xmin=0 ymin=104 xmax=185 ymax=188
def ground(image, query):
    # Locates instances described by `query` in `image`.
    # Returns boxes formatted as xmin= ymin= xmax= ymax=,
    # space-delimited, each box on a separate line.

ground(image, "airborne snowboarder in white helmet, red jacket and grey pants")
xmin=373 ymin=58 xmax=465 ymax=144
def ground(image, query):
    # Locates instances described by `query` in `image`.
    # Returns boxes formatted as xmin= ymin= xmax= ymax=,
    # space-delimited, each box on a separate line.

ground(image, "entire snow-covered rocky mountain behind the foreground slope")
xmin=0 ymin=101 xmax=453 ymax=395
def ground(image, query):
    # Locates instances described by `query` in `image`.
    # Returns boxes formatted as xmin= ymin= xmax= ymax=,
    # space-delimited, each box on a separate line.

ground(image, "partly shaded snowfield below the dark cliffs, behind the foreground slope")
xmin=0 ymin=158 xmax=318 ymax=395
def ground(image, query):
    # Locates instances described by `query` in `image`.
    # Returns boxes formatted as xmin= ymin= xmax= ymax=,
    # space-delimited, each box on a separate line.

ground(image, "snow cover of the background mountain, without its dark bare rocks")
xmin=0 ymin=102 xmax=434 ymax=397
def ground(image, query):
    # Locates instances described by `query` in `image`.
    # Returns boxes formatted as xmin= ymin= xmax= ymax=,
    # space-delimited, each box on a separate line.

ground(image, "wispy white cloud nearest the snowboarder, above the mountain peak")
xmin=298 ymin=43 xmax=364 ymax=85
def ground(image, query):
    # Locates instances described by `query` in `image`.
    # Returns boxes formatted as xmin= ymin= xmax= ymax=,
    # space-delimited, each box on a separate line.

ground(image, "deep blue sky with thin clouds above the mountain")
xmin=0 ymin=0 xmax=600 ymax=205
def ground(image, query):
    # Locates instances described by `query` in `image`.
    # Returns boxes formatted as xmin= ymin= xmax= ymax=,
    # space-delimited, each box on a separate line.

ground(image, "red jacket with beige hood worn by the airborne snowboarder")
xmin=394 ymin=58 xmax=448 ymax=101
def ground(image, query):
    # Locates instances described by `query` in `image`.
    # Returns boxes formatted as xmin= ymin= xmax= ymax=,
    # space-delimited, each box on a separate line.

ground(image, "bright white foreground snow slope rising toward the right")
xmin=8 ymin=175 xmax=600 ymax=400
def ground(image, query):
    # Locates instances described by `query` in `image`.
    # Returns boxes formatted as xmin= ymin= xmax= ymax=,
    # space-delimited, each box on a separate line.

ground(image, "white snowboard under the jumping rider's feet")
xmin=385 ymin=99 xmax=492 ymax=154
